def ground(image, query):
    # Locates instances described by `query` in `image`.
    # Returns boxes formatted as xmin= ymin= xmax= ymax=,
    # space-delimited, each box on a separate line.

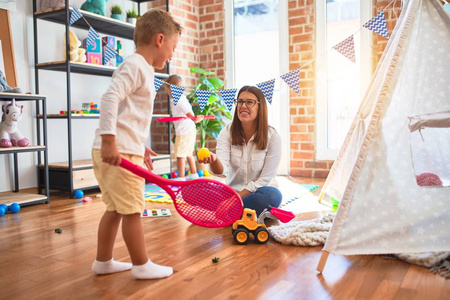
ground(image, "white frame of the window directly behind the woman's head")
xmin=224 ymin=0 xmax=290 ymax=175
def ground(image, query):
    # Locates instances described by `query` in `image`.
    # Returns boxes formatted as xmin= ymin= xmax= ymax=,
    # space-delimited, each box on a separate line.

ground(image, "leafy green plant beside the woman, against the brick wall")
xmin=187 ymin=67 xmax=232 ymax=151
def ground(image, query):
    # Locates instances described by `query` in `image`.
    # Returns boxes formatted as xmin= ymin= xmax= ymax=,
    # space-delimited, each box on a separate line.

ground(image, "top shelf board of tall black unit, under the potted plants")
xmin=35 ymin=7 xmax=135 ymax=40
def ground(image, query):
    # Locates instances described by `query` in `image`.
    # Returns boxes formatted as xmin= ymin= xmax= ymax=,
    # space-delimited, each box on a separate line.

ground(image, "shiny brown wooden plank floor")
xmin=0 ymin=179 xmax=450 ymax=299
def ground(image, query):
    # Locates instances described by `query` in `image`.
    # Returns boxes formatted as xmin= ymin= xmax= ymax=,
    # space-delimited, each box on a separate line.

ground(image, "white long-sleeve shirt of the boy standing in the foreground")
xmin=92 ymin=53 xmax=156 ymax=156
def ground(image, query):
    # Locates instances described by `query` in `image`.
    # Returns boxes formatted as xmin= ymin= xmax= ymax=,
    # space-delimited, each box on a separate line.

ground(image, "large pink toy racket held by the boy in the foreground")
xmin=120 ymin=158 xmax=243 ymax=228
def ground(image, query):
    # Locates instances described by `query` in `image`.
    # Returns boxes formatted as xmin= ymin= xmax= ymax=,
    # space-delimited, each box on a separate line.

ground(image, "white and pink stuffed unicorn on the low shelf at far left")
xmin=0 ymin=99 xmax=30 ymax=148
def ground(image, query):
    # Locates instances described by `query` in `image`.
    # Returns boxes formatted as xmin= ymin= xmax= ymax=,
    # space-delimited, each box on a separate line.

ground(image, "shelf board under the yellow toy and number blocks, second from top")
xmin=36 ymin=60 xmax=169 ymax=78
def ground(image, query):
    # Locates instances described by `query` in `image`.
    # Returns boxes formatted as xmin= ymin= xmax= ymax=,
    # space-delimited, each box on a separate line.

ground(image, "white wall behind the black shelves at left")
xmin=0 ymin=0 xmax=139 ymax=192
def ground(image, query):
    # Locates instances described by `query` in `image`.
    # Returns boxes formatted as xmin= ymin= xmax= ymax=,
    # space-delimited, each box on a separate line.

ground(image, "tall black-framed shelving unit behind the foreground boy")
xmin=33 ymin=0 xmax=171 ymax=197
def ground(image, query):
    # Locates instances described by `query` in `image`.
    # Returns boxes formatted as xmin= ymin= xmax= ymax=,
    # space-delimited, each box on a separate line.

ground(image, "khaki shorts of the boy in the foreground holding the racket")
xmin=92 ymin=149 xmax=145 ymax=215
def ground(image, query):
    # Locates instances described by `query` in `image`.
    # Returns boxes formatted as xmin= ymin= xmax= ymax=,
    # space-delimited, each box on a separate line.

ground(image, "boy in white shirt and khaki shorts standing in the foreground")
xmin=92 ymin=9 xmax=181 ymax=279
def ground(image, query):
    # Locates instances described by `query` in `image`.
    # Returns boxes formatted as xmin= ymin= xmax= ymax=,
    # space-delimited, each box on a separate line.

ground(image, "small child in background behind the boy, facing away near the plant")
xmin=166 ymin=75 xmax=203 ymax=180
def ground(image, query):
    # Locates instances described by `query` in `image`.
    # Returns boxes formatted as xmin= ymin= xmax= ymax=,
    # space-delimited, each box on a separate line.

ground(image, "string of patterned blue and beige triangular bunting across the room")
xmin=69 ymin=0 xmax=396 ymax=111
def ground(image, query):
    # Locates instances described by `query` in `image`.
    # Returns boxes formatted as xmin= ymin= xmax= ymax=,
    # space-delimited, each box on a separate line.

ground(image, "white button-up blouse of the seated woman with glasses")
xmin=216 ymin=124 xmax=281 ymax=192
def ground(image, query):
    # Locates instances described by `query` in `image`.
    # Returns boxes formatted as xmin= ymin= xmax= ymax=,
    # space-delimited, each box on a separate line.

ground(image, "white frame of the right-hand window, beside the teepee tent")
xmin=316 ymin=0 xmax=373 ymax=160
